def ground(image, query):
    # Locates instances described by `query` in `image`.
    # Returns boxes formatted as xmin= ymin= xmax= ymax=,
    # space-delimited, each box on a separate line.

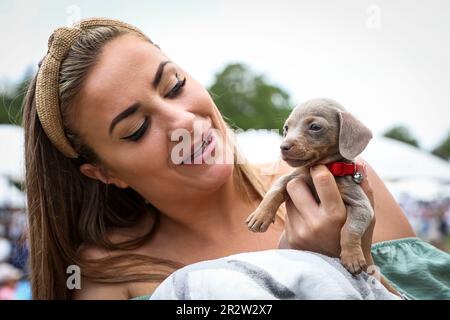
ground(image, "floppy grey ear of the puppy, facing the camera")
xmin=338 ymin=111 xmax=372 ymax=160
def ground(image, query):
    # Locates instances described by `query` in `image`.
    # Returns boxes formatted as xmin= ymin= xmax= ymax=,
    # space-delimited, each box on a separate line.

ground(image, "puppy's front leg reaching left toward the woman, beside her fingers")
xmin=245 ymin=170 xmax=299 ymax=232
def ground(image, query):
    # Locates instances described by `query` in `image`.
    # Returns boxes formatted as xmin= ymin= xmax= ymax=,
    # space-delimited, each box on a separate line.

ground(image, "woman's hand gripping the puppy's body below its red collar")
xmin=279 ymin=163 xmax=375 ymax=265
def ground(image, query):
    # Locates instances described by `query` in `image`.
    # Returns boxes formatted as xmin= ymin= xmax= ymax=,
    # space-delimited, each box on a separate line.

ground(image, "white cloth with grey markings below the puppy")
xmin=150 ymin=249 xmax=400 ymax=300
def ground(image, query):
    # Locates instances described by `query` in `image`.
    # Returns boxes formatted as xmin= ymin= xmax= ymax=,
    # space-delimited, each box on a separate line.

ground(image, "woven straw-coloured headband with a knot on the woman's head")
xmin=36 ymin=18 xmax=151 ymax=158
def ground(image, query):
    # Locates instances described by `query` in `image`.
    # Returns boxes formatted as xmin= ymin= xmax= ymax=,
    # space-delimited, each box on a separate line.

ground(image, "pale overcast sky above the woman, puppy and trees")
xmin=0 ymin=0 xmax=450 ymax=148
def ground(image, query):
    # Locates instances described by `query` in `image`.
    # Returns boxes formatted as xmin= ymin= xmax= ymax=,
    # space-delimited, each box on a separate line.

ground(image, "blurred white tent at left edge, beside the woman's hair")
xmin=0 ymin=124 xmax=24 ymax=181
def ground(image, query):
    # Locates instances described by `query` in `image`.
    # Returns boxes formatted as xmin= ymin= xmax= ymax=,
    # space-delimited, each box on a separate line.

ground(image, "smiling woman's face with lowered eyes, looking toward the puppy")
xmin=72 ymin=34 xmax=232 ymax=202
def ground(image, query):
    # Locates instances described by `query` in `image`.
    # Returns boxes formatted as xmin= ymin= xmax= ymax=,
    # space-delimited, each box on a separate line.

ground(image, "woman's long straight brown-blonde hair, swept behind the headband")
xmin=23 ymin=19 xmax=281 ymax=299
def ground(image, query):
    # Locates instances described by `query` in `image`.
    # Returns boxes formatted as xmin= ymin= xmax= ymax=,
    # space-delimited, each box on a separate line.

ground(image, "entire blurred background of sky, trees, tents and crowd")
xmin=0 ymin=0 xmax=450 ymax=299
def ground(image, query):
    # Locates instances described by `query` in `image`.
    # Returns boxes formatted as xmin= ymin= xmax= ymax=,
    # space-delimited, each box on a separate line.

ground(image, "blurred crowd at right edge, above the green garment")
xmin=398 ymin=195 xmax=450 ymax=252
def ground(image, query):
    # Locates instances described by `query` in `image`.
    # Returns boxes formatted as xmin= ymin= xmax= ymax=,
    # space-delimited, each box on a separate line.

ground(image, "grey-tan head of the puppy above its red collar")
xmin=280 ymin=99 xmax=372 ymax=167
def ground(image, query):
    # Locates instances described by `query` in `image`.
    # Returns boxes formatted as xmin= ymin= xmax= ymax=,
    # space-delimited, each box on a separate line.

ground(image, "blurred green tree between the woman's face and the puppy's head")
xmin=208 ymin=64 xmax=291 ymax=130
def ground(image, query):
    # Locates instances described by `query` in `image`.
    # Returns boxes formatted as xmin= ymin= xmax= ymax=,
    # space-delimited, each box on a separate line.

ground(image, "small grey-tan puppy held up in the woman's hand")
xmin=246 ymin=99 xmax=374 ymax=274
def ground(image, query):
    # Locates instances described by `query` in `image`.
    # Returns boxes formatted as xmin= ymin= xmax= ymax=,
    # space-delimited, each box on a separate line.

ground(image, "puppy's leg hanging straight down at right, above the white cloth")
xmin=341 ymin=199 xmax=373 ymax=275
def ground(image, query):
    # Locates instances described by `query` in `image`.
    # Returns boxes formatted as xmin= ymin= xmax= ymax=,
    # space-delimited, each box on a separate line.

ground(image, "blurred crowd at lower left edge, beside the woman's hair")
xmin=0 ymin=208 xmax=31 ymax=300
